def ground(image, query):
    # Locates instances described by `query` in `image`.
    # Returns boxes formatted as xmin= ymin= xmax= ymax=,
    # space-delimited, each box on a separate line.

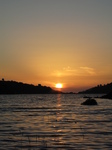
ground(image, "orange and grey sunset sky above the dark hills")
xmin=0 ymin=0 xmax=112 ymax=92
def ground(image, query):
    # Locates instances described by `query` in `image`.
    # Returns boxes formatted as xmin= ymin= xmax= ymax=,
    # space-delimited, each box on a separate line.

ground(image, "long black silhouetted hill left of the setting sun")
xmin=0 ymin=80 xmax=62 ymax=94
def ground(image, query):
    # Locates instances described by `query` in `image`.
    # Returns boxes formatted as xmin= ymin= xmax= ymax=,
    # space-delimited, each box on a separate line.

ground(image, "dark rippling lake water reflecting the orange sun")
xmin=0 ymin=94 xmax=112 ymax=150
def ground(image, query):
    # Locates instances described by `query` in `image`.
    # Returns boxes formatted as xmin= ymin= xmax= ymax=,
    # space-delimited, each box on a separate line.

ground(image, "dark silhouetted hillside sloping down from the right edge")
xmin=79 ymin=82 xmax=112 ymax=94
